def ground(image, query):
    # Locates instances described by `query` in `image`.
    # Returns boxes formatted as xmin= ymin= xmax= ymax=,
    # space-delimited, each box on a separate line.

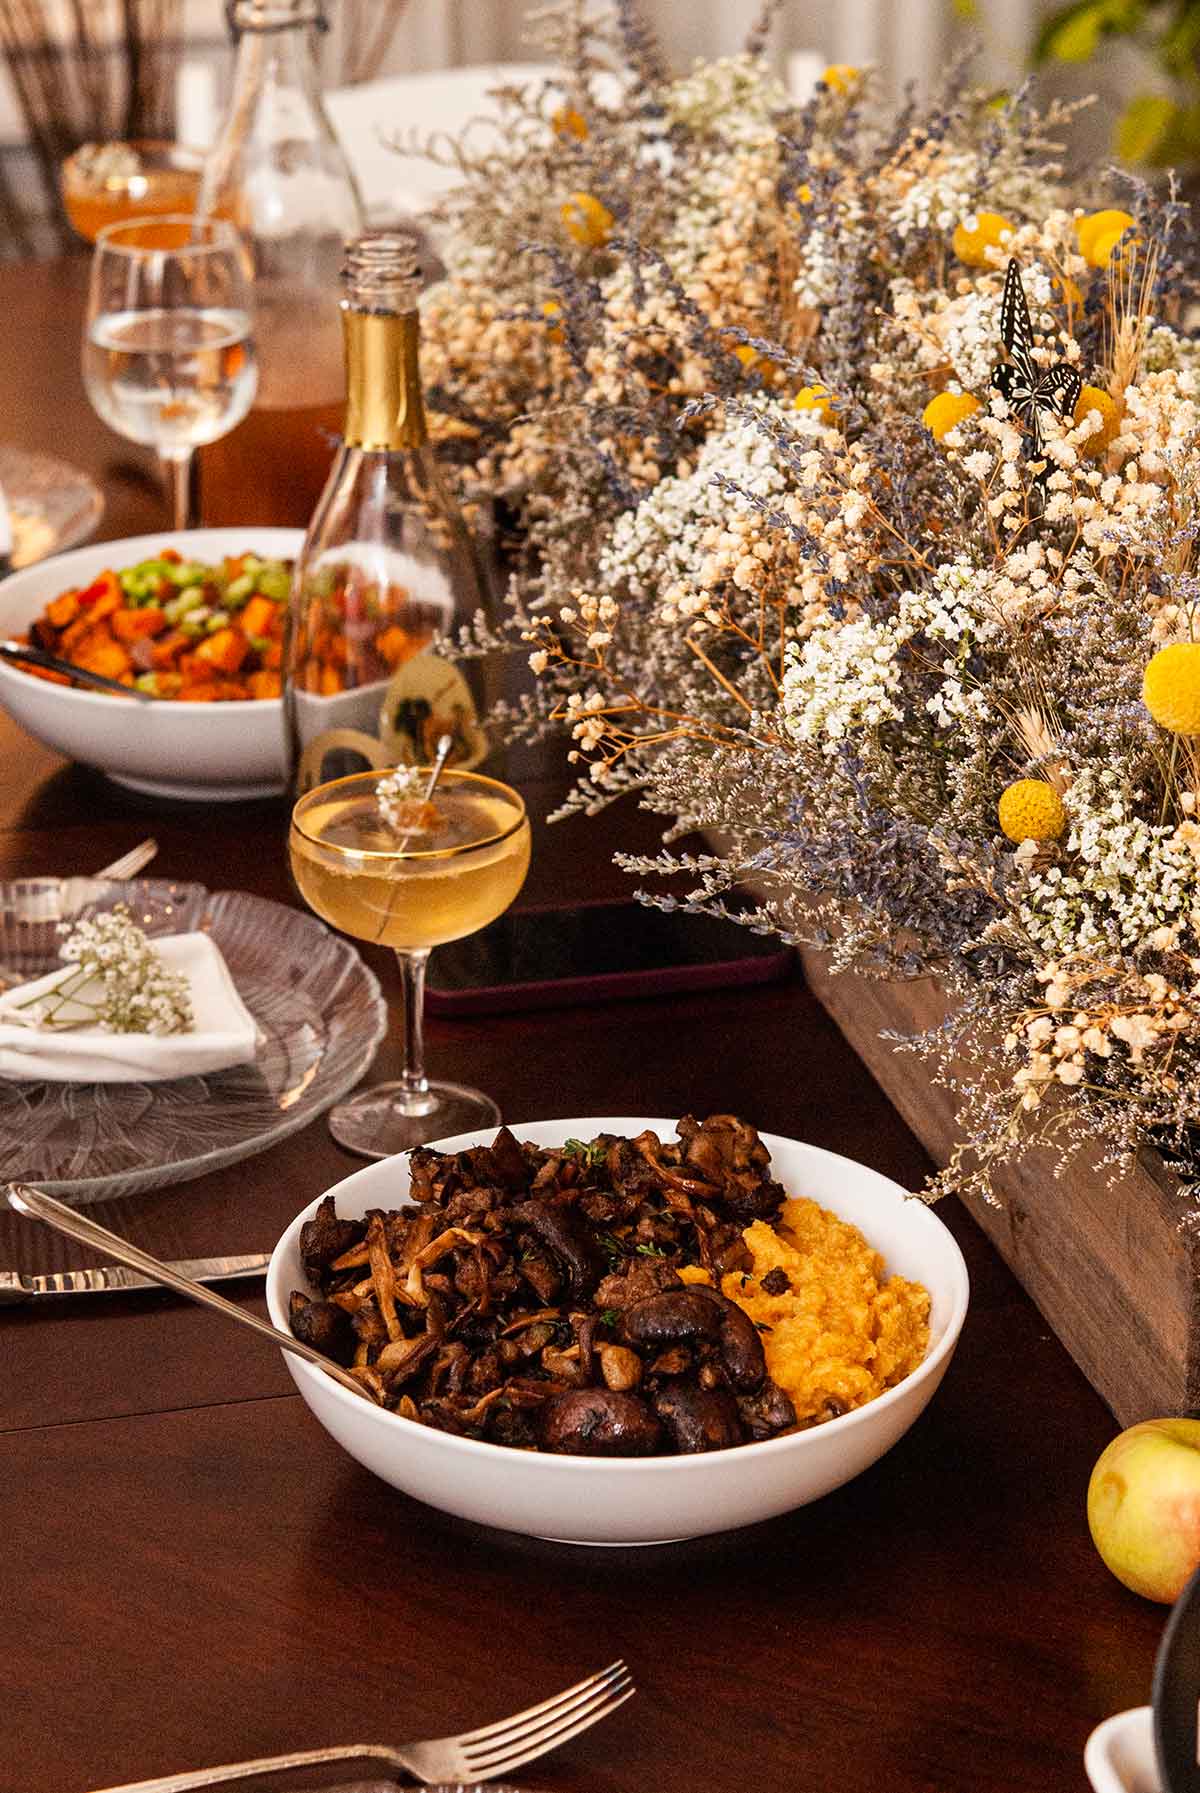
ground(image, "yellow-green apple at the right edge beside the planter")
xmin=1087 ymin=1420 xmax=1200 ymax=1605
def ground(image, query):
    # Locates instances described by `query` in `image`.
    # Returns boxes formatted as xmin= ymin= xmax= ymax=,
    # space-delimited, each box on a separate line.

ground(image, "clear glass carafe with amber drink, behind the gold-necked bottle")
xmin=197 ymin=0 xmax=362 ymax=525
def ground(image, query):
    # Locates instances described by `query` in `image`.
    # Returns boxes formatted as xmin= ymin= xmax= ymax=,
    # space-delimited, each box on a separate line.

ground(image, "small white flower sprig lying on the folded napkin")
xmin=12 ymin=904 xmax=196 ymax=1035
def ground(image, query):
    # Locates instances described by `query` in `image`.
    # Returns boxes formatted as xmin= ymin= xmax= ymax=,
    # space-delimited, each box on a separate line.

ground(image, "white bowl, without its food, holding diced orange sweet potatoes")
xmin=0 ymin=525 xmax=303 ymax=801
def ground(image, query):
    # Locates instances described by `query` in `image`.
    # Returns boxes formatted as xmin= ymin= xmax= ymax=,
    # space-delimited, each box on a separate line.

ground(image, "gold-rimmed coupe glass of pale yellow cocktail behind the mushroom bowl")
xmin=289 ymin=767 xmax=529 ymax=1158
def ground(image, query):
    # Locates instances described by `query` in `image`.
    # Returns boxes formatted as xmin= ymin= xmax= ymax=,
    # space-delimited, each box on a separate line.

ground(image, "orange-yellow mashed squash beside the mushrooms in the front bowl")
xmin=680 ymin=1200 xmax=929 ymax=1425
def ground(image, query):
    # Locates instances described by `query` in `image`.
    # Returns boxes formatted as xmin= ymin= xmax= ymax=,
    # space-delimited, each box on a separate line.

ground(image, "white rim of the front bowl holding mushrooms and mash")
xmin=267 ymin=1115 xmax=970 ymax=1476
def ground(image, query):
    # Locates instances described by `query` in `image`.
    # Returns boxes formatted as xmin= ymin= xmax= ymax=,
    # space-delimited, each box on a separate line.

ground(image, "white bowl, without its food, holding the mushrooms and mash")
xmin=267 ymin=1115 xmax=969 ymax=1544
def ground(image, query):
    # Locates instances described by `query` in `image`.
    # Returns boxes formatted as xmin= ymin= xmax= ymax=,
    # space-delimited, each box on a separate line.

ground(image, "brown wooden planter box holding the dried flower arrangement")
xmin=804 ymin=952 xmax=1200 ymax=1425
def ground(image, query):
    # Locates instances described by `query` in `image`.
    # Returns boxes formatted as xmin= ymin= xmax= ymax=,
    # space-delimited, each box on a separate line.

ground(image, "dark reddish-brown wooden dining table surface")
xmin=0 ymin=264 xmax=1164 ymax=1793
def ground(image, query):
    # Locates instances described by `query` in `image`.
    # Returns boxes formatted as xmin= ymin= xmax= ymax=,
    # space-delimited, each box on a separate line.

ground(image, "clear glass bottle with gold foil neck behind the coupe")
xmin=283 ymin=231 xmax=491 ymax=796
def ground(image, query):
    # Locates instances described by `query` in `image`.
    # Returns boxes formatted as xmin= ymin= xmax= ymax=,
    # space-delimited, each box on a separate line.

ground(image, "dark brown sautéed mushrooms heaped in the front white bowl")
xmin=291 ymin=1115 xmax=810 ymax=1456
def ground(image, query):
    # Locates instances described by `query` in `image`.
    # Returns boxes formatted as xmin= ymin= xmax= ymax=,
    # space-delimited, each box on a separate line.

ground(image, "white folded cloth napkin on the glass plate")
xmin=0 ymin=934 xmax=258 ymax=1083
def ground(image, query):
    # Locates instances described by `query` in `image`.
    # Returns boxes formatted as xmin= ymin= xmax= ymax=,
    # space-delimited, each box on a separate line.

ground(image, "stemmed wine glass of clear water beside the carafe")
xmin=83 ymin=213 xmax=258 ymax=529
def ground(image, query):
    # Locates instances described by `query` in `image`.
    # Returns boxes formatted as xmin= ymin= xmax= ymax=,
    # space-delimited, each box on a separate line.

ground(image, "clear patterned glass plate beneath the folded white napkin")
xmin=0 ymin=879 xmax=387 ymax=1203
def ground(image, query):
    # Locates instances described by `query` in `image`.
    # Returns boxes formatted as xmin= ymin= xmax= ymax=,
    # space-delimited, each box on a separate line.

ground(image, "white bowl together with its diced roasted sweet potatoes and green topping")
xmin=0 ymin=527 xmax=303 ymax=800
